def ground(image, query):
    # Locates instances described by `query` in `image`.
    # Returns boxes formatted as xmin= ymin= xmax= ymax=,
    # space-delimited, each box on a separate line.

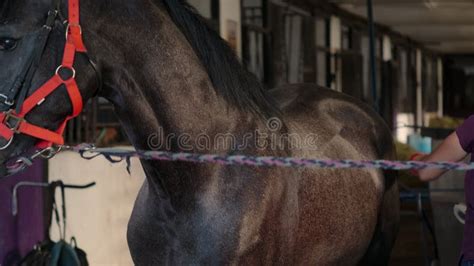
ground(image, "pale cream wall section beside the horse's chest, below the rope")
xmin=49 ymin=152 xmax=144 ymax=266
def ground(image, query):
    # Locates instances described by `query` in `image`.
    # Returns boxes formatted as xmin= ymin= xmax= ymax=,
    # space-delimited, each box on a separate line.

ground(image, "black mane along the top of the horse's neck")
xmin=163 ymin=0 xmax=279 ymax=118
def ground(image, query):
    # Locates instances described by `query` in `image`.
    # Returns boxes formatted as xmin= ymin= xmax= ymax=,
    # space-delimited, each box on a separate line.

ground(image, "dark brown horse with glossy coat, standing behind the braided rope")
xmin=0 ymin=0 xmax=399 ymax=265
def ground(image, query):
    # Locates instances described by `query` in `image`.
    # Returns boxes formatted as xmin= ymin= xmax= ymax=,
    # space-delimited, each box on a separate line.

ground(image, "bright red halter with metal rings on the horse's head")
xmin=0 ymin=0 xmax=87 ymax=148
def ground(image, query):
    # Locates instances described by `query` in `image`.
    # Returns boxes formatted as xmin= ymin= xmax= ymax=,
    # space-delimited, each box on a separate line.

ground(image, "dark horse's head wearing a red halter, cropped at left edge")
xmin=0 ymin=0 xmax=98 ymax=175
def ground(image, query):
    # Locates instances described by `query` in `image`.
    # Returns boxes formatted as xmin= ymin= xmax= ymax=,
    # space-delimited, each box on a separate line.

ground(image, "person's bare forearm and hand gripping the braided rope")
xmin=418 ymin=132 xmax=467 ymax=181
